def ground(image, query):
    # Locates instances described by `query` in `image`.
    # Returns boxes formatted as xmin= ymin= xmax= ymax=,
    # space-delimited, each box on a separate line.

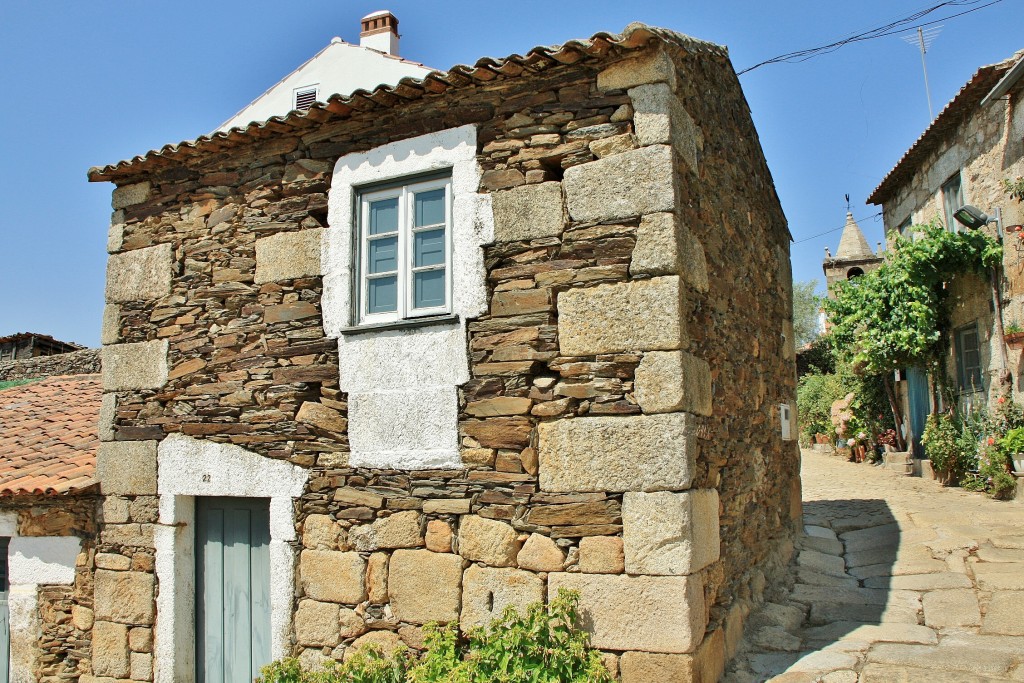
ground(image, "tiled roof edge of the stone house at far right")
xmin=867 ymin=53 xmax=1022 ymax=204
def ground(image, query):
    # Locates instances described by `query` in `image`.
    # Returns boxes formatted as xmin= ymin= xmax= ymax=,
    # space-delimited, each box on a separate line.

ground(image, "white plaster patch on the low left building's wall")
xmin=0 ymin=510 xmax=82 ymax=683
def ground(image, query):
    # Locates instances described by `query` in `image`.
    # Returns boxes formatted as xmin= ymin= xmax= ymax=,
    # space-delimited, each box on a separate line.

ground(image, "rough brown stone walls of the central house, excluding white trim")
xmin=93 ymin=37 xmax=799 ymax=682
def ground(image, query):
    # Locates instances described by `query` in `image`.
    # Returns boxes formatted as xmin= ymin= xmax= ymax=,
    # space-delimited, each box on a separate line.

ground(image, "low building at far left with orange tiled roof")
xmin=0 ymin=375 xmax=101 ymax=683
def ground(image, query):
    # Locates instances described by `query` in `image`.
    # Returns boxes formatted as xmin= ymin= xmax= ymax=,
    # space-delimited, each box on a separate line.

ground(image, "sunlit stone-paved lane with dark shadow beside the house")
xmin=724 ymin=451 xmax=1024 ymax=683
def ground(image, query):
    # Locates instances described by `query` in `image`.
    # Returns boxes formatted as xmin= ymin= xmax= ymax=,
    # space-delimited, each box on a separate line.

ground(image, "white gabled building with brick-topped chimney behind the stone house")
xmin=217 ymin=10 xmax=433 ymax=131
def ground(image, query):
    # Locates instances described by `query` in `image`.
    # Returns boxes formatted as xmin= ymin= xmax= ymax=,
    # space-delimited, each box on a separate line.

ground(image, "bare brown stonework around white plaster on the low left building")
xmin=2 ymin=496 xmax=97 ymax=683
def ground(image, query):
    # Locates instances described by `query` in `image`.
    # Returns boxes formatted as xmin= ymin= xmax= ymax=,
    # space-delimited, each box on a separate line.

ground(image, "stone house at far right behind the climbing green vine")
xmin=867 ymin=52 xmax=1024 ymax=442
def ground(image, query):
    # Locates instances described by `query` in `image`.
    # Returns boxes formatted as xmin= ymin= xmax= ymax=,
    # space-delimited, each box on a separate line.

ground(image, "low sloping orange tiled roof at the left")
xmin=0 ymin=375 xmax=102 ymax=496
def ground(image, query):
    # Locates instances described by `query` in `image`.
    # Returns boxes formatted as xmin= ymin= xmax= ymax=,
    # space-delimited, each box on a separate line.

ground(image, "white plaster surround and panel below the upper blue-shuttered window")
xmin=323 ymin=126 xmax=495 ymax=469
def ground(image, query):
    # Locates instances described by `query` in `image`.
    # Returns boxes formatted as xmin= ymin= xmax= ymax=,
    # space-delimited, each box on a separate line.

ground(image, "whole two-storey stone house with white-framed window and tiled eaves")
xmin=83 ymin=25 xmax=800 ymax=683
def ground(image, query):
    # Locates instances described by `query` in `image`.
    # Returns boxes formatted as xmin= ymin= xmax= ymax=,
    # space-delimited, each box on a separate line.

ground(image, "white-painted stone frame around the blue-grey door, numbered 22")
xmin=154 ymin=434 xmax=308 ymax=683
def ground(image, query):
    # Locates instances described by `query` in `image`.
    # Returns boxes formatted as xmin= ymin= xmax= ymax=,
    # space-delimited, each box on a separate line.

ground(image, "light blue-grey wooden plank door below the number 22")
xmin=196 ymin=498 xmax=270 ymax=683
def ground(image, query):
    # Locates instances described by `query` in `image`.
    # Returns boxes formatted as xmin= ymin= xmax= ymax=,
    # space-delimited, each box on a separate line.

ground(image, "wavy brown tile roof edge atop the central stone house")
xmin=88 ymin=24 xmax=728 ymax=181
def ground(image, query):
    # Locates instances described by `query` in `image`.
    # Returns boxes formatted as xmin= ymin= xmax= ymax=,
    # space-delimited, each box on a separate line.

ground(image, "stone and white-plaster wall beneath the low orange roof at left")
xmin=0 ymin=495 xmax=97 ymax=683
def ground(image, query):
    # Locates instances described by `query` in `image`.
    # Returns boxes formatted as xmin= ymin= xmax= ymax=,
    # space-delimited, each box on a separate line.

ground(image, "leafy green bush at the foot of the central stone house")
xmin=258 ymin=590 xmax=613 ymax=683
